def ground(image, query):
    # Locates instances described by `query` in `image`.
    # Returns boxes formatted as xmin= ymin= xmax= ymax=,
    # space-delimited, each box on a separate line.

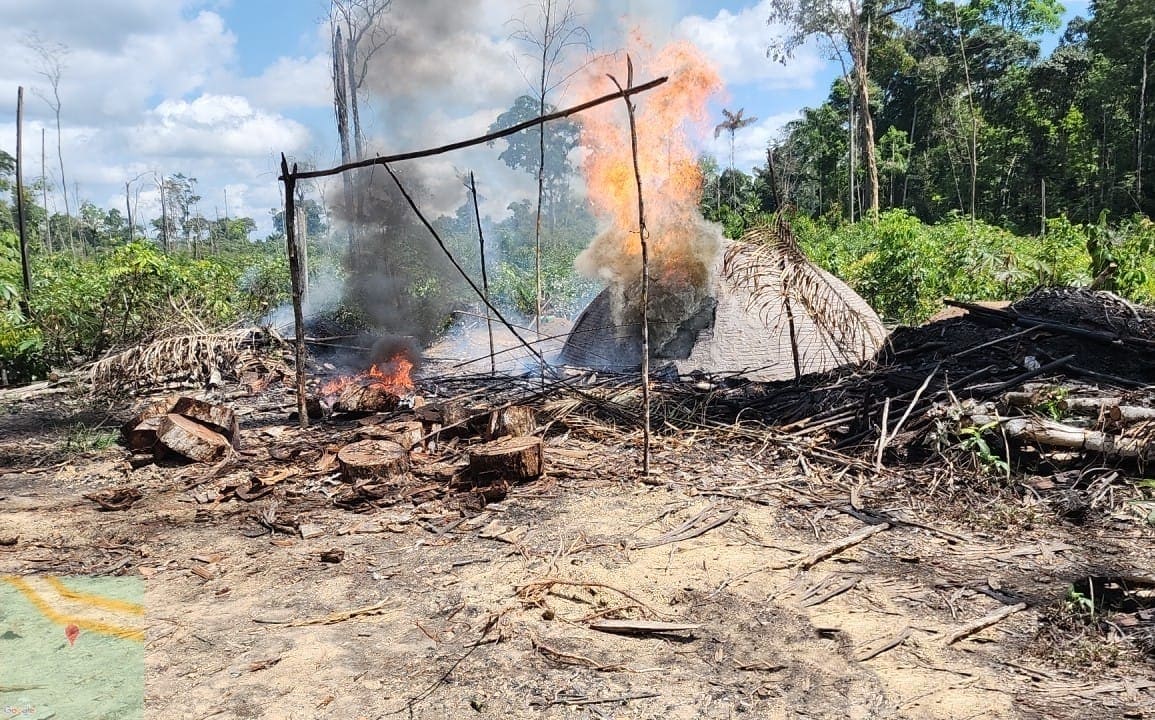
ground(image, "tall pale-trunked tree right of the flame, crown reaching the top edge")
xmin=768 ymin=0 xmax=915 ymax=217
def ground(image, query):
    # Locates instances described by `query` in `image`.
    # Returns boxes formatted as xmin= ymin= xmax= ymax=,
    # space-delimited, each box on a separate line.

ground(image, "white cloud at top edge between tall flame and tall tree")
xmin=677 ymin=0 xmax=826 ymax=89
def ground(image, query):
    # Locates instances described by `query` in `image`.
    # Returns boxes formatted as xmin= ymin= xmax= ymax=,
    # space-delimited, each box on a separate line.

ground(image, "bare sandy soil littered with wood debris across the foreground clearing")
xmin=0 ymin=376 xmax=1155 ymax=720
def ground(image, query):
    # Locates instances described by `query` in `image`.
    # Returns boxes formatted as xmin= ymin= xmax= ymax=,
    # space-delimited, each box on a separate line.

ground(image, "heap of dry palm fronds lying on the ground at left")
xmin=90 ymin=328 xmax=278 ymax=394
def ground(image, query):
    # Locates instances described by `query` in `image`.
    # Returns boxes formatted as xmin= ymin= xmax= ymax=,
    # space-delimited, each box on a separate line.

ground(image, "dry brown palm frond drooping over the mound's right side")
xmin=723 ymin=217 xmax=885 ymax=374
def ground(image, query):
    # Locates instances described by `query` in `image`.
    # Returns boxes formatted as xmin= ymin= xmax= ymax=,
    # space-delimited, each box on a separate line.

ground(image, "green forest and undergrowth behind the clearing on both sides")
xmin=0 ymin=0 xmax=1155 ymax=381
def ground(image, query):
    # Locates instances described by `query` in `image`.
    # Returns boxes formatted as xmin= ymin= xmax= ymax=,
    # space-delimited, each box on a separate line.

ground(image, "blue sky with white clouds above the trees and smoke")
xmin=0 ymin=0 xmax=1086 ymax=232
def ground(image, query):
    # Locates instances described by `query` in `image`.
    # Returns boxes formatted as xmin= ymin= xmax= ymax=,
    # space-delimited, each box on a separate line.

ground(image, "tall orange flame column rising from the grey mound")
xmin=576 ymin=31 xmax=722 ymax=347
